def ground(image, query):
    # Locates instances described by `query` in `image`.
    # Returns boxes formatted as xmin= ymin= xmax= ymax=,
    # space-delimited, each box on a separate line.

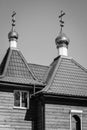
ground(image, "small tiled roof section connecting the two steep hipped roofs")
xmin=28 ymin=63 xmax=49 ymax=82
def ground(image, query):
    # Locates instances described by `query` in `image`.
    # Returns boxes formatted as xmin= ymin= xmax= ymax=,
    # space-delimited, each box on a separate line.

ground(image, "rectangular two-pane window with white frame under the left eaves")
xmin=14 ymin=90 xmax=29 ymax=108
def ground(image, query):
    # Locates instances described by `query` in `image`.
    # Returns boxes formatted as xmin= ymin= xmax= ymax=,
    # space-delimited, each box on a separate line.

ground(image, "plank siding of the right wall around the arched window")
xmin=45 ymin=104 xmax=87 ymax=130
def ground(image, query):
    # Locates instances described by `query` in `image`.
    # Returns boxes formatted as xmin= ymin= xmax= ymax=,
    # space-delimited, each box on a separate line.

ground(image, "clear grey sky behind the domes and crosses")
xmin=0 ymin=0 xmax=87 ymax=68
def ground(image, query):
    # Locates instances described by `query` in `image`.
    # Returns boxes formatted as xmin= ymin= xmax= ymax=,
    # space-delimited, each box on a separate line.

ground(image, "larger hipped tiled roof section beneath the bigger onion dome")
xmin=41 ymin=56 xmax=87 ymax=97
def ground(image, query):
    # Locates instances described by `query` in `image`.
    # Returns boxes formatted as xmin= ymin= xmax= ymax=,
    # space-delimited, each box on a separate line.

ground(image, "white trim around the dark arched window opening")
xmin=70 ymin=110 xmax=83 ymax=130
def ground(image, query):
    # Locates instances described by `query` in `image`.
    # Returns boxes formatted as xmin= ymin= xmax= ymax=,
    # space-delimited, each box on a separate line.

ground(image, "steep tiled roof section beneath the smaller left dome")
xmin=0 ymin=48 xmax=42 ymax=85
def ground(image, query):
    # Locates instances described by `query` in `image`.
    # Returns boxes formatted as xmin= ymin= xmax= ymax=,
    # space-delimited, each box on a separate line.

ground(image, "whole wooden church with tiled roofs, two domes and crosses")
xmin=0 ymin=11 xmax=87 ymax=130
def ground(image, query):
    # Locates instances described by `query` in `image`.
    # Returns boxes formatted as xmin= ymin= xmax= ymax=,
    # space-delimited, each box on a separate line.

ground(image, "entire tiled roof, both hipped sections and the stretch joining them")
xmin=0 ymin=48 xmax=87 ymax=97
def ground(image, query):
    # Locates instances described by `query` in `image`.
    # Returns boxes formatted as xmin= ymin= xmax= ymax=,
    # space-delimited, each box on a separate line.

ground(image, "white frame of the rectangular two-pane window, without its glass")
xmin=14 ymin=90 xmax=30 ymax=109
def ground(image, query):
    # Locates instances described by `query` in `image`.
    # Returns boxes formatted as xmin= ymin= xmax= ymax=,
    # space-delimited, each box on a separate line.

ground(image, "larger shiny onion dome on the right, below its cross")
xmin=55 ymin=32 xmax=70 ymax=48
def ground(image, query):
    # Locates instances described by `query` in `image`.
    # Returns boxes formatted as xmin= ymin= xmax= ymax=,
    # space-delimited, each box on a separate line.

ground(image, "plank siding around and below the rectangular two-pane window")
xmin=0 ymin=91 xmax=32 ymax=130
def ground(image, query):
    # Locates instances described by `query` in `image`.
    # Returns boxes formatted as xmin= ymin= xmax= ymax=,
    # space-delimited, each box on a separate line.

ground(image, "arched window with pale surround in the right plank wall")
xmin=70 ymin=110 xmax=82 ymax=130
